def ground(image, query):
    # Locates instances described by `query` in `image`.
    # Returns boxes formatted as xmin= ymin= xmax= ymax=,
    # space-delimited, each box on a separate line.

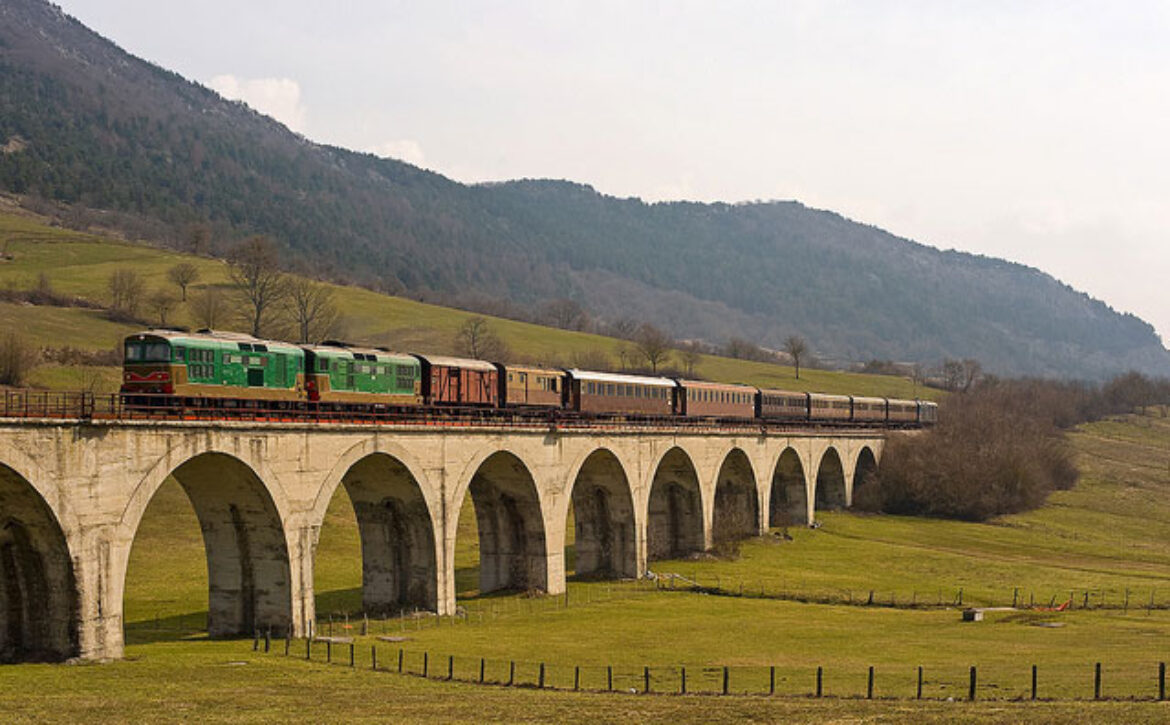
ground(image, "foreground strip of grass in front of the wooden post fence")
xmin=0 ymin=641 xmax=1166 ymax=724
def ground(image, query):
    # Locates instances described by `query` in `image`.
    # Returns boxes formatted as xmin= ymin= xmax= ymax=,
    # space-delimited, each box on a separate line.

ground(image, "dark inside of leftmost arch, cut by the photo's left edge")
xmin=0 ymin=464 xmax=80 ymax=662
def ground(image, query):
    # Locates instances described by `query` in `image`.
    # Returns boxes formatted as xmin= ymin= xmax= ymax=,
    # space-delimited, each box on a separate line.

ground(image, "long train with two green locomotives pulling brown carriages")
xmin=122 ymin=330 xmax=938 ymax=428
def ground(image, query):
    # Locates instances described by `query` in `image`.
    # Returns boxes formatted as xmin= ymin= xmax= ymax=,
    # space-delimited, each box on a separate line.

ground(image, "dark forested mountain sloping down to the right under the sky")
xmin=0 ymin=0 xmax=1170 ymax=377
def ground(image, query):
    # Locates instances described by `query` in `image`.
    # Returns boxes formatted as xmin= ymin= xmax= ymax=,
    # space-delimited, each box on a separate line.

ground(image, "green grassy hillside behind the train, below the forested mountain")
xmin=0 ymin=212 xmax=937 ymax=398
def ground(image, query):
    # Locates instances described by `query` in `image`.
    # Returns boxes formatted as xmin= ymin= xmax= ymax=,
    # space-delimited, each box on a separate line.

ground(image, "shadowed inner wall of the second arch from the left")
xmin=122 ymin=451 xmax=293 ymax=636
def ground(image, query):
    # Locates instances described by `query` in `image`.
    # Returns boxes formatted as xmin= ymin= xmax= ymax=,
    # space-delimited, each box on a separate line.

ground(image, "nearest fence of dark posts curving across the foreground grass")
xmin=260 ymin=635 xmax=1166 ymax=700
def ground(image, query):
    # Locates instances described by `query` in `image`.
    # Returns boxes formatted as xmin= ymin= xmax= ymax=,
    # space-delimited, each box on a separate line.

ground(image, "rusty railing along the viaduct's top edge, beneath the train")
xmin=0 ymin=389 xmax=904 ymax=434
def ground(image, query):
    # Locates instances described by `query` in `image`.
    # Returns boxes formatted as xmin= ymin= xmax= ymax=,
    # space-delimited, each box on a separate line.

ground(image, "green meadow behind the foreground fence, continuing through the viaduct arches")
xmin=105 ymin=416 xmax=1170 ymax=720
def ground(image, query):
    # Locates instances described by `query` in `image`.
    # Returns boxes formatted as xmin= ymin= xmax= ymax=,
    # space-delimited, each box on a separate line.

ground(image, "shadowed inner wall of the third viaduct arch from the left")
xmin=342 ymin=453 xmax=439 ymax=614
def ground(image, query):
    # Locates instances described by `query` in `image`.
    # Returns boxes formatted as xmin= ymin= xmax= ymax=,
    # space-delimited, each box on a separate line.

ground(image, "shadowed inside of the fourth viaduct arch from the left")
xmin=452 ymin=450 xmax=549 ymax=593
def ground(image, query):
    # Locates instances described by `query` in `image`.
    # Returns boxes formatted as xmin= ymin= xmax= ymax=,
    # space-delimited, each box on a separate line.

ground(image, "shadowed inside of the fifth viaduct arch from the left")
xmin=565 ymin=448 xmax=638 ymax=578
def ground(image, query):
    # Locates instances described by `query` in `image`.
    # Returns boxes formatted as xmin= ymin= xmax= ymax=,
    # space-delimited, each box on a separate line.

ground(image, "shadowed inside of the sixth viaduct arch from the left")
xmin=646 ymin=447 xmax=706 ymax=560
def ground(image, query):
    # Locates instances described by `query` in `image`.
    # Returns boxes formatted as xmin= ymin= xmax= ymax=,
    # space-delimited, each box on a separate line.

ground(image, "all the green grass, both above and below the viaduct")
xmin=13 ymin=205 xmax=1170 ymax=723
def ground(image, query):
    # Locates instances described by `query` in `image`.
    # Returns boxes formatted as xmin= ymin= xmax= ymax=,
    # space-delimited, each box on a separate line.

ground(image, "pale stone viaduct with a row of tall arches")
xmin=0 ymin=420 xmax=883 ymax=661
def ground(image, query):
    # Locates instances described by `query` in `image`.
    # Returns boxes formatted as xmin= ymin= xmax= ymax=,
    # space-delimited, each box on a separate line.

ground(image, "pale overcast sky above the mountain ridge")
xmin=59 ymin=0 xmax=1170 ymax=341
